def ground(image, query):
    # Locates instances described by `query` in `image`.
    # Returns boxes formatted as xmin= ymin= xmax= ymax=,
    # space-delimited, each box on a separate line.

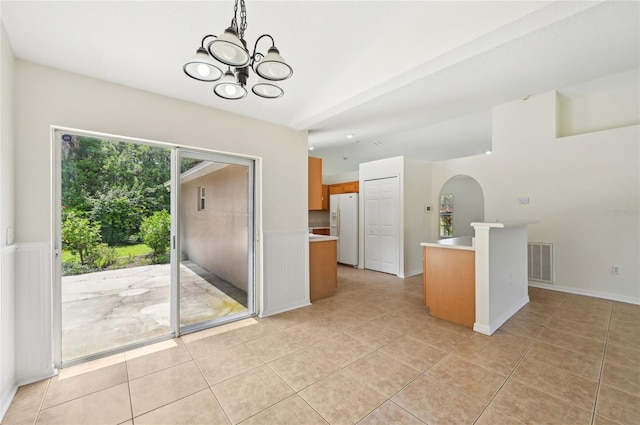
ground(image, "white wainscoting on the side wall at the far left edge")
xmin=0 ymin=245 xmax=18 ymax=418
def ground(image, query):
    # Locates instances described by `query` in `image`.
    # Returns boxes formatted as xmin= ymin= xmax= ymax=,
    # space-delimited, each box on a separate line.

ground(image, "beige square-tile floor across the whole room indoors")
xmin=2 ymin=267 xmax=640 ymax=425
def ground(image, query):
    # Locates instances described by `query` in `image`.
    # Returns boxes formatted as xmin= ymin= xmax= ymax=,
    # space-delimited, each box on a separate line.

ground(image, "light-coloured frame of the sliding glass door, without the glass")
xmin=50 ymin=126 xmax=261 ymax=368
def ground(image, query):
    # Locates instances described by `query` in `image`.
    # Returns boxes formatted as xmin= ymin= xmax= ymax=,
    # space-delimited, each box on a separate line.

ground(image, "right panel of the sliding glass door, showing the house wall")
xmin=178 ymin=150 xmax=254 ymax=332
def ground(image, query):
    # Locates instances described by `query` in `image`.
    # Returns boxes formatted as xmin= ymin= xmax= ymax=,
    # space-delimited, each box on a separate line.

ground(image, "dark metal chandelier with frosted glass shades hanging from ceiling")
xmin=182 ymin=0 xmax=293 ymax=99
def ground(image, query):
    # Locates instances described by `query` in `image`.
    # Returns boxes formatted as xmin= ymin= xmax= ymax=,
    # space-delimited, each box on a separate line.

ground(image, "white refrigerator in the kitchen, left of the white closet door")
xmin=329 ymin=193 xmax=358 ymax=266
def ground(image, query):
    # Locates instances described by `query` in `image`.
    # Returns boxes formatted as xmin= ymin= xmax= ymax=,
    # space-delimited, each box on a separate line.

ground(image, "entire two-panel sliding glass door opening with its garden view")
xmin=53 ymin=130 xmax=255 ymax=367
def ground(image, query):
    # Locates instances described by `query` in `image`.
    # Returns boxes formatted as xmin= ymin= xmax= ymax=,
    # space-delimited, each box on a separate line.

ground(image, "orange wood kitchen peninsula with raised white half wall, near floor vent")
xmin=420 ymin=221 xmax=536 ymax=335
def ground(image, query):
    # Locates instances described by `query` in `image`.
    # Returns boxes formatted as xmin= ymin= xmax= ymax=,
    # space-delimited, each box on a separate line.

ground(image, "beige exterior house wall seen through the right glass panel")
xmin=180 ymin=165 xmax=248 ymax=292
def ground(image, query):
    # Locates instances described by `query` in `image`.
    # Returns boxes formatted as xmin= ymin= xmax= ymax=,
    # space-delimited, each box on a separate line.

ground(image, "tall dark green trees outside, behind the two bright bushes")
xmin=62 ymin=136 xmax=171 ymax=245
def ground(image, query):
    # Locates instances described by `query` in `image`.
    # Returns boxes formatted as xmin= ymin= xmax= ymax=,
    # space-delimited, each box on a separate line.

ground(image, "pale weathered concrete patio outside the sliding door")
xmin=62 ymin=262 xmax=247 ymax=361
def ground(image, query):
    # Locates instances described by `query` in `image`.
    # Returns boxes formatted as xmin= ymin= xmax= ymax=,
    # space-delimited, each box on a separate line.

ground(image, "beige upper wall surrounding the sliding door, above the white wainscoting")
xmin=15 ymin=60 xmax=308 ymax=242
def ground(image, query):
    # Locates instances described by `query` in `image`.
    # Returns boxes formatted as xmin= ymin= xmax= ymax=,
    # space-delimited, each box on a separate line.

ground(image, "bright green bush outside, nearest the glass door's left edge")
xmin=62 ymin=210 xmax=101 ymax=265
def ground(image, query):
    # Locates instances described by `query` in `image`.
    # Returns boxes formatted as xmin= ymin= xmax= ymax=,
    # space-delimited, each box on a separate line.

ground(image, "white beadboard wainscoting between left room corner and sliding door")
xmin=15 ymin=242 xmax=55 ymax=385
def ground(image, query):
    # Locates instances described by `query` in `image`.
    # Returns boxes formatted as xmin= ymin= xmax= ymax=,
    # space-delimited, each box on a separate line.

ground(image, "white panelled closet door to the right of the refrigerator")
xmin=364 ymin=177 xmax=400 ymax=274
